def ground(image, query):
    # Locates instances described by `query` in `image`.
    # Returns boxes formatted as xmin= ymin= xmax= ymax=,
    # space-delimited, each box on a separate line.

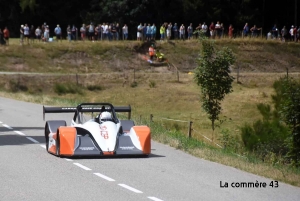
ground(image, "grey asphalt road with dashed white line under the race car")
xmin=0 ymin=97 xmax=300 ymax=201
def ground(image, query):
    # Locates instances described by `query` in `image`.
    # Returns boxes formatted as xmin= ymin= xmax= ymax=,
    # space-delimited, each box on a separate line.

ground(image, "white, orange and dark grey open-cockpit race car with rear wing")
xmin=43 ymin=103 xmax=151 ymax=157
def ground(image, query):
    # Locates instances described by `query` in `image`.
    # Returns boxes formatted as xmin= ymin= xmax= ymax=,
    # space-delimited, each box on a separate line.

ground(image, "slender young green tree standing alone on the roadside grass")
xmin=194 ymin=38 xmax=235 ymax=140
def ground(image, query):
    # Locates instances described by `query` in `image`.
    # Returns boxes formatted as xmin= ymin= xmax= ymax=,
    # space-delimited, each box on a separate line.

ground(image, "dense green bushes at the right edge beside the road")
xmin=242 ymin=77 xmax=300 ymax=166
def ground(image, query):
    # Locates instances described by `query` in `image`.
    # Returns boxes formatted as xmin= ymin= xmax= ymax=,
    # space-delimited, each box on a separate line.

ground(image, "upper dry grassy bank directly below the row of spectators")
xmin=0 ymin=39 xmax=300 ymax=73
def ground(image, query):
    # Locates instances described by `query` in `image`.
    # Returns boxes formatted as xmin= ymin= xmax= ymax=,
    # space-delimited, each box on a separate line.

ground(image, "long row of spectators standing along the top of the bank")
xmin=0 ymin=21 xmax=300 ymax=45
